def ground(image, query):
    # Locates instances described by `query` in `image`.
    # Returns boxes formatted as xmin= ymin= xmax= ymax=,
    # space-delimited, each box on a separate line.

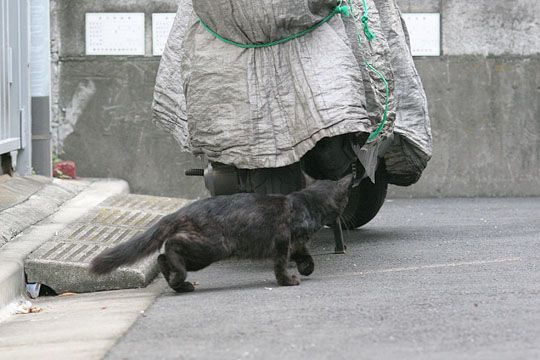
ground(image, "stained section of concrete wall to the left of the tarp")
xmin=51 ymin=0 xmax=205 ymax=197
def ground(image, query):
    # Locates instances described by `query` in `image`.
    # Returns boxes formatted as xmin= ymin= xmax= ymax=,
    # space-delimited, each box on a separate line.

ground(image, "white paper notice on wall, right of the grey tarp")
xmin=402 ymin=13 xmax=441 ymax=56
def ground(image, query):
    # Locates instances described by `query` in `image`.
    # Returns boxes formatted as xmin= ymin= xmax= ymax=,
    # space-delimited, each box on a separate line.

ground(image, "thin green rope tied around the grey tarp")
xmin=199 ymin=0 xmax=390 ymax=142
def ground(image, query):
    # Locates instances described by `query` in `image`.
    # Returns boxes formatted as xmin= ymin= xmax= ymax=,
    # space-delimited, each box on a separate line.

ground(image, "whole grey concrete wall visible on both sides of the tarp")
xmin=51 ymin=0 xmax=540 ymax=197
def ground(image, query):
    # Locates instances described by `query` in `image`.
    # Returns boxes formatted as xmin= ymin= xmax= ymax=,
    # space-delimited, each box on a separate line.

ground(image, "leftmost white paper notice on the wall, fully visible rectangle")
xmin=86 ymin=13 xmax=145 ymax=55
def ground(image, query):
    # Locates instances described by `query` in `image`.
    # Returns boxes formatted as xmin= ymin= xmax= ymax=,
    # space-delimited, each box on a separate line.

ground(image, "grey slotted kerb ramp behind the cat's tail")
xmin=25 ymin=194 xmax=194 ymax=293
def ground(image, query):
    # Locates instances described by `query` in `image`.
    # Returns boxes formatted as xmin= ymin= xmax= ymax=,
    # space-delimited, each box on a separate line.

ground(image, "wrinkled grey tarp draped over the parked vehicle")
xmin=153 ymin=0 xmax=431 ymax=184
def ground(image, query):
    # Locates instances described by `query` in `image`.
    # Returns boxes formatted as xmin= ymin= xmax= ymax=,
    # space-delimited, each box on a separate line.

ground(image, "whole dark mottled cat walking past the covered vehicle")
xmin=90 ymin=175 xmax=352 ymax=292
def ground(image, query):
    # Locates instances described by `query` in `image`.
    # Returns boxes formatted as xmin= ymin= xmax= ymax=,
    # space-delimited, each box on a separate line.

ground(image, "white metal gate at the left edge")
xmin=0 ymin=0 xmax=31 ymax=174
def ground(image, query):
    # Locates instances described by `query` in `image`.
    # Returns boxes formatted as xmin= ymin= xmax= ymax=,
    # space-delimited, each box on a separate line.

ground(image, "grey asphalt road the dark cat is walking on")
xmin=108 ymin=198 xmax=540 ymax=360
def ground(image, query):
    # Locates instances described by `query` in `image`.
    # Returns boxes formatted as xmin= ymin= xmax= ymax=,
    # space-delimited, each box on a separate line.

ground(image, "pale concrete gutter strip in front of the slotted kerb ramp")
xmin=0 ymin=281 xmax=166 ymax=360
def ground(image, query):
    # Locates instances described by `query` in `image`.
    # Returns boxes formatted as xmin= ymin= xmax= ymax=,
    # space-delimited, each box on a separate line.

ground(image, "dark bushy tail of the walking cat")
xmin=90 ymin=214 xmax=174 ymax=275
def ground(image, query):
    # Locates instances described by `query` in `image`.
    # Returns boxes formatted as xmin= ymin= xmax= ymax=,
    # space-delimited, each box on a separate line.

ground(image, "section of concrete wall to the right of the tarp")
xmin=390 ymin=0 xmax=540 ymax=196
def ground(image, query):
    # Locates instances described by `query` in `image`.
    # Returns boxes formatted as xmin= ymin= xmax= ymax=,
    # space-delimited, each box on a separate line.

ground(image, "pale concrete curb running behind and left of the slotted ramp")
xmin=0 ymin=179 xmax=129 ymax=316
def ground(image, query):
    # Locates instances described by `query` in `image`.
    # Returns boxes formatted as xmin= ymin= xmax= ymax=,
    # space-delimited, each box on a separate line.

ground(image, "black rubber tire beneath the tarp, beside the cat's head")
xmin=341 ymin=163 xmax=388 ymax=230
